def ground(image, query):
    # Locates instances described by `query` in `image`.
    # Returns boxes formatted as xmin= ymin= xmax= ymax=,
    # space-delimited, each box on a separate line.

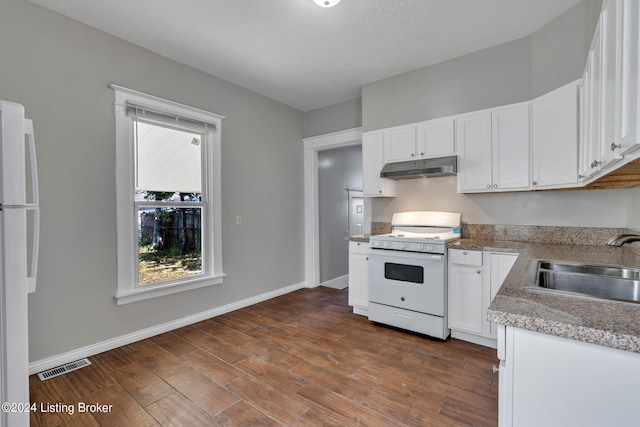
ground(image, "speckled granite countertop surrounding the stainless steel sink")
xmin=448 ymin=239 xmax=640 ymax=353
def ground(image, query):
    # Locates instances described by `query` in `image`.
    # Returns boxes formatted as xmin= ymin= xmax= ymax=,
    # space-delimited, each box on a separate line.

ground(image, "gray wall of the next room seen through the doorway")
xmin=318 ymin=146 xmax=362 ymax=283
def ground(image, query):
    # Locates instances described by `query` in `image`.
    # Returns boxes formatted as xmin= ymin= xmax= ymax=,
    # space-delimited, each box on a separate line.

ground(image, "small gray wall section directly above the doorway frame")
xmin=304 ymin=98 xmax=362 ymax=138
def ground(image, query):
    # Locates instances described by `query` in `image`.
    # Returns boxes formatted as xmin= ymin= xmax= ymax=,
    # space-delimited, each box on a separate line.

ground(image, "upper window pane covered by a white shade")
xmin=135 ymin=120 xmax=202 ymax=196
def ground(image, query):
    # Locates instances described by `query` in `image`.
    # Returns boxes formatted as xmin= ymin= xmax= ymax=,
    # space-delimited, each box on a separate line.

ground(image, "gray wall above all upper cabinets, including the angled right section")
xmin=362 ymin=0 xmax=602 ymax=131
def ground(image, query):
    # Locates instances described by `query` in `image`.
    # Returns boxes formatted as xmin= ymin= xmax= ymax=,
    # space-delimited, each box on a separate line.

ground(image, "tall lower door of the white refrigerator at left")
xmin=0 ymin=208 xmax=29 ymax=427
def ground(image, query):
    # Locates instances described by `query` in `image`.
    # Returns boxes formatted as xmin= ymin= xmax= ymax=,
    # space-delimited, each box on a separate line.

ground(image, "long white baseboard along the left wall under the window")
xmin=29 ymin=282 xmax=307 ymax=375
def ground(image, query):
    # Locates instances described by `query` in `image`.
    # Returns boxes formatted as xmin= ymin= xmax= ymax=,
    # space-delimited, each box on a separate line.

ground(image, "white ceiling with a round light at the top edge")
xmin=31 ymin=0 xmax=580 ymax=111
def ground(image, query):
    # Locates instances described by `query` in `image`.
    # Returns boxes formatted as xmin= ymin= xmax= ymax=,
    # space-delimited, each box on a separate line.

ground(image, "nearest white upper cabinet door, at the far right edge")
xmin=616 ymin=0 xmax=640 ymax=154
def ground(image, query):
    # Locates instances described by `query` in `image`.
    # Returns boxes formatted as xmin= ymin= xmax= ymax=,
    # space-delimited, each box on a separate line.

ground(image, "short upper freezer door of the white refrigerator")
xmin=0 ymin=101 xmax=27 ymax=206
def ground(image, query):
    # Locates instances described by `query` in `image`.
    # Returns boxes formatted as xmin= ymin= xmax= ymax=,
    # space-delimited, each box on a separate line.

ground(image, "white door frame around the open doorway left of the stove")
xmin=302 ymin=127 xmax=362 ymax=288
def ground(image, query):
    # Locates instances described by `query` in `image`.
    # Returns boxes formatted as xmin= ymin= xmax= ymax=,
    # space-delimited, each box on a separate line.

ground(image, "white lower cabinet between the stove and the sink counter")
xmin=448 ymin=249 xmax=518 ymax=348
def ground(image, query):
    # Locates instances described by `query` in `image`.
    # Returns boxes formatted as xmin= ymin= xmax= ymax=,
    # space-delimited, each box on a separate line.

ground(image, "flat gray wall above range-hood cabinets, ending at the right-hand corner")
xmin=362 ymin=37 xmax=531 ymax=131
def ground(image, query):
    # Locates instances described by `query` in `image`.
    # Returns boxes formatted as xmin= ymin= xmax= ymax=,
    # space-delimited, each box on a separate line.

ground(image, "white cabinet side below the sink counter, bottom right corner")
xmin=498 ymin=326 xmax=640 ymax=427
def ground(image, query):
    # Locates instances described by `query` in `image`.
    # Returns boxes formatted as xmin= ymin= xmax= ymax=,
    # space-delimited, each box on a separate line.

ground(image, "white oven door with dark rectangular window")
xmin=369 ymin=249 xmax=447 ymax=317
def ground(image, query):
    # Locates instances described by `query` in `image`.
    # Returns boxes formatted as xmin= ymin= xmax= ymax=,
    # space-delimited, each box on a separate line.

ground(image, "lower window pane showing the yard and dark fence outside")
xmin=138 ymin=206 xmax=202 ymax=286
